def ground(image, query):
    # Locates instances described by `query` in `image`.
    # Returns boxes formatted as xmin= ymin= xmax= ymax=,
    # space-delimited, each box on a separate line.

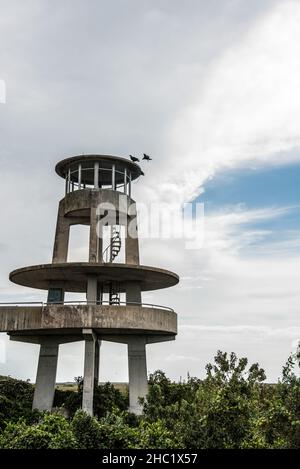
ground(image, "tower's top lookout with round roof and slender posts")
xmin=55 ymin=155 xmax=143 ymax=197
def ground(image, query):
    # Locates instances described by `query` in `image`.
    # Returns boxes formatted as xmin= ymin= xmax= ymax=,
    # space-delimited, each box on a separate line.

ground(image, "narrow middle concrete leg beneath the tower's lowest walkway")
xmin=82 ymin=329 xmax=97 ymax=415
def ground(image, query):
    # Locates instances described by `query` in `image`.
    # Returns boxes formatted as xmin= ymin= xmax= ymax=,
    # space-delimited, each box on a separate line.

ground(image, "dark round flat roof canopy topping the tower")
xmin=55 ymin=155 xmax=142 ymax=184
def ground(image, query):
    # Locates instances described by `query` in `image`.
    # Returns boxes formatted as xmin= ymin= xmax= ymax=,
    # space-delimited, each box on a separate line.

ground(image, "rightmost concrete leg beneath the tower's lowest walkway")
xmin=128 ymin=337 xmax=148 ymax=415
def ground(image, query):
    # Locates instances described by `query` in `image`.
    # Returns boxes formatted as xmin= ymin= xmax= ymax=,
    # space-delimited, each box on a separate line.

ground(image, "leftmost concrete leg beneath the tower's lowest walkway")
xmin=32 ymin=338 xmax=59 ymax=411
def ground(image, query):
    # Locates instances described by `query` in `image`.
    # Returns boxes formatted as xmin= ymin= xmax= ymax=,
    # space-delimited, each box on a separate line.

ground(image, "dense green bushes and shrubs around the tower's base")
xmin=0 ymin=352 xmax=300 ymax=449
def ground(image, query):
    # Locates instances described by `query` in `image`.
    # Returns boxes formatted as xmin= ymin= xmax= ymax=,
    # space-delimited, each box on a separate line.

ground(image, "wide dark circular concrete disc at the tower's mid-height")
xmin=9 ymin=262 xmax=179 ymax=293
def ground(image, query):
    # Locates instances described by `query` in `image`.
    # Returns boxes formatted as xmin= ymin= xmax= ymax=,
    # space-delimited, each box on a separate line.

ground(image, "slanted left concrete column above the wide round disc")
xmin=52 ymin=200 xmax=70 ymax=263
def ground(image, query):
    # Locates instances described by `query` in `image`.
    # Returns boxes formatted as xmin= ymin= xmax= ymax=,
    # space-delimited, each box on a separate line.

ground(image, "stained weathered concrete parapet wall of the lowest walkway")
xmin=0 ymin=304 xmax=177 ymax=335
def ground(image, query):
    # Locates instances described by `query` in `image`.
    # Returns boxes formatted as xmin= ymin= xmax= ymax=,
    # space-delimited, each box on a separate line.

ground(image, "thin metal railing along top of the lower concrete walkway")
xmin=0 ymin=300 xmax=174 ymax=312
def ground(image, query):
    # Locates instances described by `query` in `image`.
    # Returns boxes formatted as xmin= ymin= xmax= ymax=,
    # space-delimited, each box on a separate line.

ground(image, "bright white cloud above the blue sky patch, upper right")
xmin=137 ymin=0 xmax=300 ymax=204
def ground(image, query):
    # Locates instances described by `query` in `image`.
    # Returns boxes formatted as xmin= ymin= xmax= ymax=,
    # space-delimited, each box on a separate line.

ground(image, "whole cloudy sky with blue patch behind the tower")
xmin=0 ymin=0 xmax=300 ymax=381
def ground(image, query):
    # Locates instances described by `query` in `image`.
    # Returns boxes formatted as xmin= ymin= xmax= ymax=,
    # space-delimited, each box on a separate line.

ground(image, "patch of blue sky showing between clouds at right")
xmin=196 ymin=163 xmax=300 ymax=254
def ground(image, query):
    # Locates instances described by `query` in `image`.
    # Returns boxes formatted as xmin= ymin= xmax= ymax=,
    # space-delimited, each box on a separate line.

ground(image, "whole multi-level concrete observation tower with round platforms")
xmin=0 ymin=155 xmax=179 ymax=414
